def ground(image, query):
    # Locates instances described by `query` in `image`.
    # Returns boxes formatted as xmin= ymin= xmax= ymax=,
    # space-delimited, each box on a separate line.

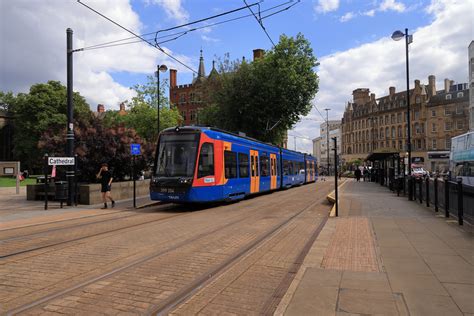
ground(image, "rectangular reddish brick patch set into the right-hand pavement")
xmin=321 ymin=217 xmax=380 ymax=272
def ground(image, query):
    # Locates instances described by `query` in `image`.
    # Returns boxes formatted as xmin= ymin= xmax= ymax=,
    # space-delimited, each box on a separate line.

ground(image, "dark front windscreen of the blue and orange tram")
xmin=156 ymin=133 xmax=199 ymax=177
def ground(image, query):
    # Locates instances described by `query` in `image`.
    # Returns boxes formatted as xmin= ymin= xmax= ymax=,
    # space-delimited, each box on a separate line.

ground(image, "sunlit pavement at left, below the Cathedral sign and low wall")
xmin=0 ymin=187 xmax=156 ymax=230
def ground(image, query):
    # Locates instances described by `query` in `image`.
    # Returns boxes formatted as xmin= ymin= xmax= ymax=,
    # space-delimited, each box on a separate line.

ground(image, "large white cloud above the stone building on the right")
xmin=289 ymin=0 xmax=472 ymax=152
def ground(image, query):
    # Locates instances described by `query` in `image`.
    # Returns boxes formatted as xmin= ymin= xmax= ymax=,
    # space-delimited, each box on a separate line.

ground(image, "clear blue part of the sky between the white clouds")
xmin=110 ymin=0 xmax=431 ymax=85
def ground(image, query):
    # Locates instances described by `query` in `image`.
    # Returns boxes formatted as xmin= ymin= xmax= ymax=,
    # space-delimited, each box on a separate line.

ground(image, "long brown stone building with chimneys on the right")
xmin=342 ymin=75 xmax=469 ymax=171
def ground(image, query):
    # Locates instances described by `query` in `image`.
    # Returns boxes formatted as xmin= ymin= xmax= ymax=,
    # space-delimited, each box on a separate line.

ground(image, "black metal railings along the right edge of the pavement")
xmin=390 ymin=177 xmax=474 ymax=225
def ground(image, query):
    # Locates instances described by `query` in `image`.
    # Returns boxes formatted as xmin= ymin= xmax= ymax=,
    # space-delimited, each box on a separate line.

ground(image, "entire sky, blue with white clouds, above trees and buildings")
xmin=0 ymin=0 xmax=474 ymax=152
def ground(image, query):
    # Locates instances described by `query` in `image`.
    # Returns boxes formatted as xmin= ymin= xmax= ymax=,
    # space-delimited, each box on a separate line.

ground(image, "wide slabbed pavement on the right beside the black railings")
xmin=275 ymin=180 xmax=474 ymax=316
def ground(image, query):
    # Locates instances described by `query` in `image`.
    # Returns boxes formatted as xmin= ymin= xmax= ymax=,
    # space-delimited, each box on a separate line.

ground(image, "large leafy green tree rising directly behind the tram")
xmin=200 ymin=34 xmax=318 ymax=143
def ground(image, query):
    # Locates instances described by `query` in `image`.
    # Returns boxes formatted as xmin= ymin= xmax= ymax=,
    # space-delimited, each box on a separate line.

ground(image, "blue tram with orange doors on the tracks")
xmin=150 ymin=126 xmax=317 ymax=203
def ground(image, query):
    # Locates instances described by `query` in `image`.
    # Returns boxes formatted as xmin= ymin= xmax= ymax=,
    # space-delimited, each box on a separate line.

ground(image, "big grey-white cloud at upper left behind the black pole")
xmin=0 ymin=0 xmax=192 ymax=109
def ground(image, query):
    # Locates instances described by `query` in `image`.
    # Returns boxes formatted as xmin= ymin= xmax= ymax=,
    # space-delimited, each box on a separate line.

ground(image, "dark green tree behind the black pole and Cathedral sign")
xmin=10 ymin=81 xmax=91 ymax=169
